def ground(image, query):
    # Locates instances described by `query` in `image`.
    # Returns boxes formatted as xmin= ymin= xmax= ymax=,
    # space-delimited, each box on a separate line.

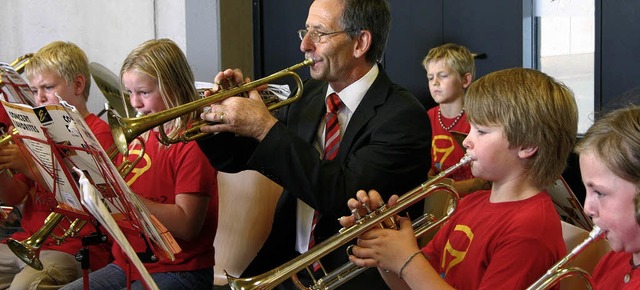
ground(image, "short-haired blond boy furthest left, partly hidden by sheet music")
xmin=0 ymin=41 xmax=113 ymax=289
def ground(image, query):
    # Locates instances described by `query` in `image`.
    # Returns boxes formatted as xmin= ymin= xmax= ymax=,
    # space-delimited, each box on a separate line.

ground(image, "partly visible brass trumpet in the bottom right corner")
xmin=527 ymin=226 xmax=604 ymax=290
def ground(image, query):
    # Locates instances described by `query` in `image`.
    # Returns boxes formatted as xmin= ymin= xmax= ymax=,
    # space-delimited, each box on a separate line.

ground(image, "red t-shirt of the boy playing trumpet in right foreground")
xmin=422 ymin=190 xmax=566 ymax=289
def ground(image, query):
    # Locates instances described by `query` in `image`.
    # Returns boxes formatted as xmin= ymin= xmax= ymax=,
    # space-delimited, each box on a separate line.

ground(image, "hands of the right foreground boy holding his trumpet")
xmin=340 ymin=190 xmax=428 ymax=280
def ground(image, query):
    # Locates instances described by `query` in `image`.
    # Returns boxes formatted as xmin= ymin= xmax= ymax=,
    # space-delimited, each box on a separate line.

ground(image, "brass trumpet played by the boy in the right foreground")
xmin=227 ymin=156 xmax=472 ymax=290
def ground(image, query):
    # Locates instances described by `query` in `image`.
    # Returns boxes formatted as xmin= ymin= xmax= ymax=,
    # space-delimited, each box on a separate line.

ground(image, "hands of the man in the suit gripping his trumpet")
xmin=200 ymin=69 xmax=278 ymax=141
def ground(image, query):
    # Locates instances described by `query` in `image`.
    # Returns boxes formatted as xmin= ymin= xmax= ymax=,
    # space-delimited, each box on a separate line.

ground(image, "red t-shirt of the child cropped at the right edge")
xmin=592 ymin=251 xmax=640 ymax=290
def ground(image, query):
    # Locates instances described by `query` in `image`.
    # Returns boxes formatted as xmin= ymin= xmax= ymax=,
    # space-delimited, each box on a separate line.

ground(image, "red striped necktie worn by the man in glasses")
xmin=309 ymin=93 xmax=342 ymax=271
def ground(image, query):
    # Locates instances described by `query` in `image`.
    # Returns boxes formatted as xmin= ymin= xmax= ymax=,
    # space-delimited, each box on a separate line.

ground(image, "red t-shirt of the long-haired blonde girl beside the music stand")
xmin=112 ymin=132 xmax=218 ymax=280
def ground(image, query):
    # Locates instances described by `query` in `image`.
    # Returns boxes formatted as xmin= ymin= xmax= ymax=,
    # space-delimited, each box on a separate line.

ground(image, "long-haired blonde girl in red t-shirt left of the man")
xmin=63 ymin=39 xmax=218 ymax=290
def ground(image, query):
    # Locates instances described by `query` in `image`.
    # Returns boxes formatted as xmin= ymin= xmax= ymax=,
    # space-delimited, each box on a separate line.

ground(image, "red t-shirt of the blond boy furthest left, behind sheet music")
xmin=0 ymin=112 xmax=113 ymax=270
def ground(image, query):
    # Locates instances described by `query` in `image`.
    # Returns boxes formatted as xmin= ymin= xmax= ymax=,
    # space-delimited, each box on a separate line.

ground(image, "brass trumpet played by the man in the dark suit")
xmin=107 ymin=59 xmax=313 ymax=154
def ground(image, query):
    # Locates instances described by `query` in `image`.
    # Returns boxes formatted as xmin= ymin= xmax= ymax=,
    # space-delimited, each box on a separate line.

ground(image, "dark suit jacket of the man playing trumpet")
xmin=198 ymin=69 xmax=431 ymax=289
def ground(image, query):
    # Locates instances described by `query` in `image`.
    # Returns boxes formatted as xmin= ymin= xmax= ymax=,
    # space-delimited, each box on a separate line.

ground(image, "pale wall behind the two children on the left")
xmin=0 ymin=0 xmax=220 ymax=118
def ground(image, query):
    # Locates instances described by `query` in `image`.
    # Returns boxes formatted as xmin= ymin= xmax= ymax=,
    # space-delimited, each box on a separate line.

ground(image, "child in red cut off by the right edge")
xmin=575 ymin=106 xmax=640 ymax=289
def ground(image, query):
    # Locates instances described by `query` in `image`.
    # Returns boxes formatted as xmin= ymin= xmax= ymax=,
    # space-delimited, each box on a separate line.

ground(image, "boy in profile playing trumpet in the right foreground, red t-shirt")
xmin=340 ymin=68 xmax=578 ymax=289
